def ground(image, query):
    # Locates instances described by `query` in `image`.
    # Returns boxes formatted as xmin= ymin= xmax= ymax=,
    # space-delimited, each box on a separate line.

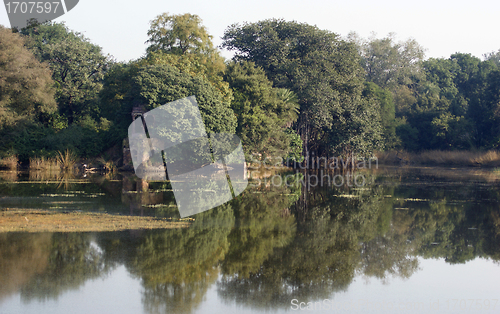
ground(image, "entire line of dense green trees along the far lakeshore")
xmin=0 ymin=13 xmax=500 ymax=161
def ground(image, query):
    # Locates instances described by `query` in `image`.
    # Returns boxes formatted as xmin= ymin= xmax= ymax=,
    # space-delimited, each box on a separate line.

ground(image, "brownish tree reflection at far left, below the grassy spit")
xmin=0 ymin=233 xmax=112 ymax=302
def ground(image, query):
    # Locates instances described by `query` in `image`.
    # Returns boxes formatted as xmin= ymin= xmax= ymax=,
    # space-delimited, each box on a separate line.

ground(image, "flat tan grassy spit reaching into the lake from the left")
xmin=0 ymin=208 xmax=192 ymax=233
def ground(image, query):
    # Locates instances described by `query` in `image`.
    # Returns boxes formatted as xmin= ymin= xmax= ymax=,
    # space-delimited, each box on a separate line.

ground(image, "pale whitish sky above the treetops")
xmin=0 ymin=0 xmax=500 ymax=61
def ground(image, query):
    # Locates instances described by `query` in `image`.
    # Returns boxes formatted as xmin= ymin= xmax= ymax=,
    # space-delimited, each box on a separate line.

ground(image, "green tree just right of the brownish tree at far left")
xmin=21 ymin=23 xmax=111 ymax=125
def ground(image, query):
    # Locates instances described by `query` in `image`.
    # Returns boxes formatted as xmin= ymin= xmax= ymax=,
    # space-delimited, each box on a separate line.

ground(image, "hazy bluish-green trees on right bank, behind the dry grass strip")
xmin=350 ymin=34 xmax=500 ymax=151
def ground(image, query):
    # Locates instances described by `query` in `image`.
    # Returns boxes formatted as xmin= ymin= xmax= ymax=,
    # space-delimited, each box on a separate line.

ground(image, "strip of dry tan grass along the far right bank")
xmin=376 ymin=150 xmax=500 ymax=167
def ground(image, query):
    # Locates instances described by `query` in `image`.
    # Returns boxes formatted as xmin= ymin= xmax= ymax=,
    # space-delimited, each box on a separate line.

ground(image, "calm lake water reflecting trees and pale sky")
xmin=0 ymin=167 xmax=500 ymax=314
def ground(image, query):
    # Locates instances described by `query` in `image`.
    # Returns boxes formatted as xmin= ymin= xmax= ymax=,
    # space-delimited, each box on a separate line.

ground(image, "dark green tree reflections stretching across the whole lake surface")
xmin=0 ymin=168 xmax=500 ymax=313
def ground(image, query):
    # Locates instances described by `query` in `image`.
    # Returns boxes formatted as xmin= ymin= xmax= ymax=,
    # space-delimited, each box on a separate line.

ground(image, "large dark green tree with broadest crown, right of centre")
xmin=223 ymin=19 xmax=380 ymax=155
